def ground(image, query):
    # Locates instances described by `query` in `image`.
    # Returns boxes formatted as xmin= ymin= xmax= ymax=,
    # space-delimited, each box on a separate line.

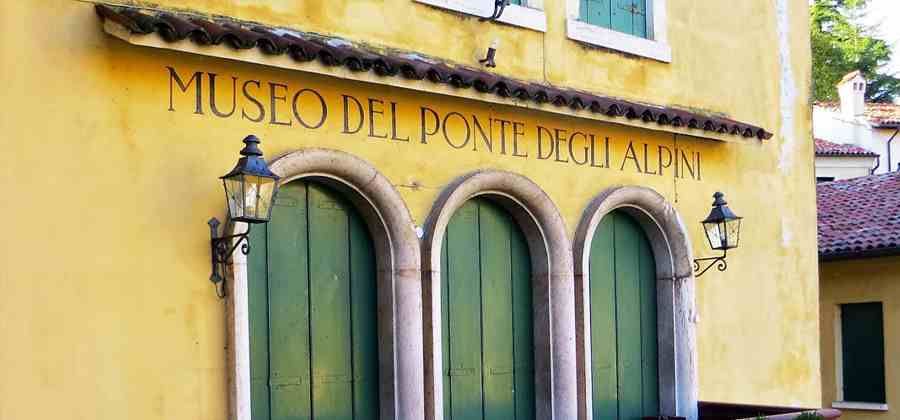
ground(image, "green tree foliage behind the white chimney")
xmin=810 ymin=0 xmax=900 ymax=102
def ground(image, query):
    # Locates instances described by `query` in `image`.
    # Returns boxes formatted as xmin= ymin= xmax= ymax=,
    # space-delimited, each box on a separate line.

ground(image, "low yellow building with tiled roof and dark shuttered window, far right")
xmin=818 ymin=172 xmax=900 ymax=419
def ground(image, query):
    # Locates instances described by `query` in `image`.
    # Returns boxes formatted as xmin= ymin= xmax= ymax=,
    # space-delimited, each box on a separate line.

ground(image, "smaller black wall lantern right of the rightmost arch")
xmin=694 ymin=192 xmax=743 ymax=277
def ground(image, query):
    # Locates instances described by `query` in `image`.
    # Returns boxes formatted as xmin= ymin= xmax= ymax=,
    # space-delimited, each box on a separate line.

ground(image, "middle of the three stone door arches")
xmin=422 ymin=170 xmax=577 ymax=420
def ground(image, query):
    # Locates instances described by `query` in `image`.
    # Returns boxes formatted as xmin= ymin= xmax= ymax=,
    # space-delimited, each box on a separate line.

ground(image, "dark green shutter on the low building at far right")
xmin=841 ymin=302 xmax=886 ymax=404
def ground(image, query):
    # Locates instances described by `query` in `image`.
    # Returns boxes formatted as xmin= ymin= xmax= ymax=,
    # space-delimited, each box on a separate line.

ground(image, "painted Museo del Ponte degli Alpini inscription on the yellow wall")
xmin=166 ymin=67 xmax=702 ymax=180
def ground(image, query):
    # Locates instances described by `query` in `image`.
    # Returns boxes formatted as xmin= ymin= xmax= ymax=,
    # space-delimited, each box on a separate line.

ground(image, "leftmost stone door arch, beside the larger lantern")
xmin=228 ymin=148 xmax=425 ymax=420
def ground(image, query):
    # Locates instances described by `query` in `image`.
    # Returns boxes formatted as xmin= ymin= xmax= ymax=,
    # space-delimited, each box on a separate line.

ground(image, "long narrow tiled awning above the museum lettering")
xmin=95 ymin=3 xmax=772 ymax=139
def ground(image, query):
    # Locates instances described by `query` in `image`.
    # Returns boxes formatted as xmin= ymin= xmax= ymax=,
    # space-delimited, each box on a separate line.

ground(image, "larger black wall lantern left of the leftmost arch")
xmin=207 ymin=135 xmax=278 ymax=297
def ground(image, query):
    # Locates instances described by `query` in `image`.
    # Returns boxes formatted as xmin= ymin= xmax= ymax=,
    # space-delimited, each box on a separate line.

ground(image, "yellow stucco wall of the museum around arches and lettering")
xmin=0 ymin=0 xmax=821 ymax=420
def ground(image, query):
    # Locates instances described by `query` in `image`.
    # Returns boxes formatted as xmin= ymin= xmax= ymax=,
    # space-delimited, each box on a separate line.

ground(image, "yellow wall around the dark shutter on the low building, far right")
xmin=819 ymin=257 xmax=900 ymax=420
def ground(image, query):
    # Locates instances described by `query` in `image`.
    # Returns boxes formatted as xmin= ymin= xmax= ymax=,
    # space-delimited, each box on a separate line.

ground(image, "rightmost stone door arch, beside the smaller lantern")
xmin=574 ymin=186 xmax=698 ymax=420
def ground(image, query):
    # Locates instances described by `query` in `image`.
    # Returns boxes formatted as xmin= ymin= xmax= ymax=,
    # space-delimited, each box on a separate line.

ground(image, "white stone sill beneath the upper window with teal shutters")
xmin=568 ymin=18 xmax=672 ymax=63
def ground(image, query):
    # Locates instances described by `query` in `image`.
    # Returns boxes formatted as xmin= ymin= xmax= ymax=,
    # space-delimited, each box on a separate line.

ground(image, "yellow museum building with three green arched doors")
xmin=0 ymin=0 xmax=824 ymax=420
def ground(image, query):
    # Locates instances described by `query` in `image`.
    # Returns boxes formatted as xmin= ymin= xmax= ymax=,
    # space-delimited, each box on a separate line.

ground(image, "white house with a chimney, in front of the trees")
xmin=813 ymin=71 xmax=900 ymax=174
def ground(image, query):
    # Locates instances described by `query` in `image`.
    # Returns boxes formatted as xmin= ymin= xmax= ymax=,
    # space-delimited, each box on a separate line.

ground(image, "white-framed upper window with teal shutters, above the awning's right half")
xmin=566 ymin=0 xmax=672 ymax=62
